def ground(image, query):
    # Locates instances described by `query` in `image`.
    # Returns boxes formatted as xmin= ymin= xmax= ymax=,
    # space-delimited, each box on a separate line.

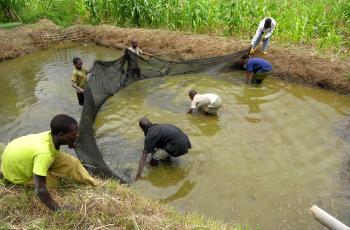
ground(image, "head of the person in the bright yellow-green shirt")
xmin=50 ymin=114 xmax=79 ymax=148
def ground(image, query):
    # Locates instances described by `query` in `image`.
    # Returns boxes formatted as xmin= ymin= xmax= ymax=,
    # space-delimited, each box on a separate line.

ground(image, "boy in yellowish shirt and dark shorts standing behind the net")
xmin=72 ymin=57 xmax=90 ymax=105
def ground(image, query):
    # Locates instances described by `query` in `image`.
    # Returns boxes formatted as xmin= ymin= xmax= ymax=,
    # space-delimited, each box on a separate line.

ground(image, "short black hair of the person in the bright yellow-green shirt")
xmin=50 ymin=114 xmax=78 ymax=135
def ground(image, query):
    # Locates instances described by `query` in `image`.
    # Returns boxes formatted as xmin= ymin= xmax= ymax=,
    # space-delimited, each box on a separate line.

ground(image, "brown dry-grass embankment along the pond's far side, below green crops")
xmin=0 ymin=20 xmax=350 ymax=94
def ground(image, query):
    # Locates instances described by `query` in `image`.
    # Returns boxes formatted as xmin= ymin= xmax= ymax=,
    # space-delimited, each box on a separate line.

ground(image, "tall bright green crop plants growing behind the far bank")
xmin=0 ymin=0 xmax=350 ymax=52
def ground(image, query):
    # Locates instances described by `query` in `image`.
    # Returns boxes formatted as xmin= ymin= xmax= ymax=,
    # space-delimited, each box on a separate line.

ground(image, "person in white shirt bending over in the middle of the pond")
xmin=187 ymin=89 xmax=222 ymax=115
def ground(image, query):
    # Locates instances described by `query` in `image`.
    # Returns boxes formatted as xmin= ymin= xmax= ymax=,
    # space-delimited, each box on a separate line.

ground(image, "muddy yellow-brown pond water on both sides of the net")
xmin=0 ymin=45 xmax=350 ymax=229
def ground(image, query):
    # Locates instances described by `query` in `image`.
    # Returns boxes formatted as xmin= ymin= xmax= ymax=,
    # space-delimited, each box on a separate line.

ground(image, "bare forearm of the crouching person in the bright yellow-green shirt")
xmin=34 ymin=174 xmax=59 ymax=211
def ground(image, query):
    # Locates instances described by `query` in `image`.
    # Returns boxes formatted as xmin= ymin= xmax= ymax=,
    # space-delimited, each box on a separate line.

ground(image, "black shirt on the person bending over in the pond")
xmin=144 ymin=124 xmax=191 ymax=157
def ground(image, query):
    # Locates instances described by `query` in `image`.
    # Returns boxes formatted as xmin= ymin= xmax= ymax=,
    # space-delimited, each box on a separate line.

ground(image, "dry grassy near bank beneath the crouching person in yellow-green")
xmin=0 ymin=181 xmax=243 ymax=230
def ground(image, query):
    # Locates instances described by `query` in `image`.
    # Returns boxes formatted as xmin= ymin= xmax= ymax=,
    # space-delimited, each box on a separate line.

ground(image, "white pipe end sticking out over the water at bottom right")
xmin=310 ymin=205 xmax=350 ymax=230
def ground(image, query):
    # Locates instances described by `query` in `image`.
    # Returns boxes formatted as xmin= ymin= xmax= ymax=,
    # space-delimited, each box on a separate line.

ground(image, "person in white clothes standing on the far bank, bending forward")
xmin=250 ymin=17 xmax=277 ymax=55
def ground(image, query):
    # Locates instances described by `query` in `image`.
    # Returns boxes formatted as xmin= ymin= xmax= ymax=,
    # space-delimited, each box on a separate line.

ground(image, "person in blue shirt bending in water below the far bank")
xmin=241 ymin=55 xmax=272 ymax=84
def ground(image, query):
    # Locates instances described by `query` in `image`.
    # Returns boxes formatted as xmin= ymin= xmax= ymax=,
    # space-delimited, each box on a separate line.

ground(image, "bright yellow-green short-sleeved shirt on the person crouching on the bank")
xmin=1 ymin=132 xmax=59 ymax=184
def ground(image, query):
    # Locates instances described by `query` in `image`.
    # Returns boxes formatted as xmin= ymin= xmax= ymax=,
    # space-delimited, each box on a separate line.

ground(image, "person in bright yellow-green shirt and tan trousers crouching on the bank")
xmin=1 ymin=114 xmax=96 ymax=211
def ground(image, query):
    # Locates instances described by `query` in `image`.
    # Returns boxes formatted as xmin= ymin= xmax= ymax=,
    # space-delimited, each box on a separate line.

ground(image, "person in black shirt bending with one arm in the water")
xmin=135 ymin=117 xmax=191 ymax=180
